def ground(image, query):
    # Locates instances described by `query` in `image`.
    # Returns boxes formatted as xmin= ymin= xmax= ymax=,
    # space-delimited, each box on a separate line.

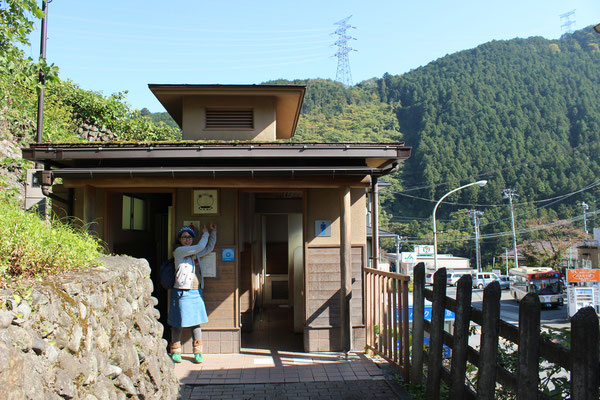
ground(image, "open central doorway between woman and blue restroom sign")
xmin=239 ymin=191 xmax=305 ymax=351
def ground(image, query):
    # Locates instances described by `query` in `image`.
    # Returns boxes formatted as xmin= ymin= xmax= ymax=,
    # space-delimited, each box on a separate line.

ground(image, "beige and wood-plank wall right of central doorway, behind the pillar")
xmin=304 ymin=188 xmax=366 ymax=351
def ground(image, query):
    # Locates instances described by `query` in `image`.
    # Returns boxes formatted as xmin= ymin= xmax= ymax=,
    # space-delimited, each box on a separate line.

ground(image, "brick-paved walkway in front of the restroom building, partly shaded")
xmin=175 ymin=349 xmax=410 ymax=400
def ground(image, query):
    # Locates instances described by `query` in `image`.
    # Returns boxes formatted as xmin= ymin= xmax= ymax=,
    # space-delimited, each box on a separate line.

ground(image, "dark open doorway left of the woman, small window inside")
xmin=106 ymin=191 xmax=173 ymax=339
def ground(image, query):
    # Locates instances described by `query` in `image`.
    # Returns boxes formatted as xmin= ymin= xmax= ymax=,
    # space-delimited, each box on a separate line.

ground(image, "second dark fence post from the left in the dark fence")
xmin=425 ymin=268 xmax=447 ymax=399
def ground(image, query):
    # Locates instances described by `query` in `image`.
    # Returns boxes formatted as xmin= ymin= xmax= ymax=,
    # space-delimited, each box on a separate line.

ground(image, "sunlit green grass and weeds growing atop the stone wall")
xmin=0 ymin=180 xmax=102 ymax=287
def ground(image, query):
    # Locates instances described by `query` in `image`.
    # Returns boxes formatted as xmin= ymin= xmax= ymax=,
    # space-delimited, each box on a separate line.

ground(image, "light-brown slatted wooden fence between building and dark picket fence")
xmin=365 ymin=268 xmax=410 ymax=381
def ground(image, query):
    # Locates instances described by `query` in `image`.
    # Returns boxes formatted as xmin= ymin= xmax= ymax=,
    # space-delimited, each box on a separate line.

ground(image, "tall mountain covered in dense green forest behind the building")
xmin=268 ymin=28 xmax=600 ymax=266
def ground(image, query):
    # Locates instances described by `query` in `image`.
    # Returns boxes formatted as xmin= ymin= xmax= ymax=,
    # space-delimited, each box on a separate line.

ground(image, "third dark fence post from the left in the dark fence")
xmin=449 ymin=275 xmax=473 ymax=399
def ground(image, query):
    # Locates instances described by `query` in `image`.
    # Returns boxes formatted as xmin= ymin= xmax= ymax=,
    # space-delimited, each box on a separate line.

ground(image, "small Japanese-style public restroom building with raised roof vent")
xmin=23 ymin=85 xmax=410 ymax=353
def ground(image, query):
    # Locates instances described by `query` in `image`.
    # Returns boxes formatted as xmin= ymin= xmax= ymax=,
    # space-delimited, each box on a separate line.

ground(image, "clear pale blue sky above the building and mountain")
xmin=27 ymin=0 xmax=600 ymax=112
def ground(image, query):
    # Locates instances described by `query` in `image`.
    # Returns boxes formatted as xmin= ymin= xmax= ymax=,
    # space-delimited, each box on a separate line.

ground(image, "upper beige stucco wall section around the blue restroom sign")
xmin=306 ymin=188 xmax=367 ymax=246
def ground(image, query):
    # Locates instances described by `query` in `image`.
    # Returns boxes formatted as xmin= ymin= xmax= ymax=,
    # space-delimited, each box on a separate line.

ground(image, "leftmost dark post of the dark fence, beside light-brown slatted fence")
xmin=410 ymin=262 xmax=425 ymax=385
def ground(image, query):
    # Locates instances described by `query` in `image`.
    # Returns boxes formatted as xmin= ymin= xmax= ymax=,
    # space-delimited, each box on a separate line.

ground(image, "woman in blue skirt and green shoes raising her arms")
xmin=168 ymin=222 xmax=217 ymax=363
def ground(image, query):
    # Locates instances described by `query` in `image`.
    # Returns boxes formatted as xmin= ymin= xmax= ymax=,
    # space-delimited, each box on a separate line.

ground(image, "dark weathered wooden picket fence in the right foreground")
xmin=412 ymin=263 xmax=600 ymax=400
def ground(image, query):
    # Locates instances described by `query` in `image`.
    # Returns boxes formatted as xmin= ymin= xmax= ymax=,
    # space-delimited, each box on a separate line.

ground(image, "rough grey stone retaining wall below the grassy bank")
xmin=0 ymin=257 xmax=179 ymax=400
